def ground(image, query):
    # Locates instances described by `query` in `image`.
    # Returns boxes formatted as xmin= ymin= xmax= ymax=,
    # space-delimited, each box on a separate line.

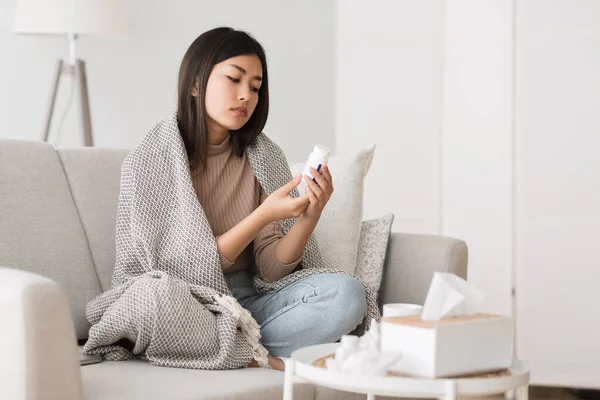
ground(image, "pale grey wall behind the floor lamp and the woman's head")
xmin=0 ymin=0 xmax=334 ymax=160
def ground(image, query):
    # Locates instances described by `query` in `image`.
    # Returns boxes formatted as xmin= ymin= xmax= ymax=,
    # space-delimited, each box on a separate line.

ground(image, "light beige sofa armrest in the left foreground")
xmin=0 ymin=267 xmax=83 ymax=400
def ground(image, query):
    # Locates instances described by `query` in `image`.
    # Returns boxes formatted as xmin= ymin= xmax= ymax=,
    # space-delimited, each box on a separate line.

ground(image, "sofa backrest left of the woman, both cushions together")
xmin=0 ymin=140 xmax=127 ymax=339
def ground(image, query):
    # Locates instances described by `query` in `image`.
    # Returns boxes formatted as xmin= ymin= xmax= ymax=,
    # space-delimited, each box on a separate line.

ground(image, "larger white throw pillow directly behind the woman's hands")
xmin=291 ymin=145 xmax=375 ymax=274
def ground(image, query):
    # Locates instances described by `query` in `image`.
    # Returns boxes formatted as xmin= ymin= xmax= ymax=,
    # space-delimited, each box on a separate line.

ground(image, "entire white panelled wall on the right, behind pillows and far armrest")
xmin=336 ymin=0 xmax=600 ymax=388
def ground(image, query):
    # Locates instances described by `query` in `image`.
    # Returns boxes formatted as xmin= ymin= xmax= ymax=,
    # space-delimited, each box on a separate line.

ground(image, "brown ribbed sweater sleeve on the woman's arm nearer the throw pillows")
xmin=254 ymin=188 xmax=302 ymax=282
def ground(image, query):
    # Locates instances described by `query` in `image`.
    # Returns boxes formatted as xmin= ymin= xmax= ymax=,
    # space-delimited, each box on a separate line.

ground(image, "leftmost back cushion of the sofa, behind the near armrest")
xmin=0 ymin=140 xmax=100 ymax=339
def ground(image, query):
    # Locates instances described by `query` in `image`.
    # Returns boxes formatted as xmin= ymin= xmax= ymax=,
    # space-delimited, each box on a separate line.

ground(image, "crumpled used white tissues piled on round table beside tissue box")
xmin=325 ymin=320 xmax=401 ymax=376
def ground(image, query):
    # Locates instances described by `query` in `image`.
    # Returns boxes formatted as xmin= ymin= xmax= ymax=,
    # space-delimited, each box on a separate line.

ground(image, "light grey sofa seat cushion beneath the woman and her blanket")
xmin=81 ymin=360 xmax=315 ymax=400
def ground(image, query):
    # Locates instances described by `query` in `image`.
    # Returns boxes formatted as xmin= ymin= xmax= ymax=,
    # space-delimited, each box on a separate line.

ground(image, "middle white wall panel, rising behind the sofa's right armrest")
xmin=440 ymin=0 xmax=513 ymax=315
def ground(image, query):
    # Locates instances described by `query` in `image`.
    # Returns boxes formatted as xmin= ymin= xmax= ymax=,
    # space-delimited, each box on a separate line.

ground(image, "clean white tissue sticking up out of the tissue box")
xmin=421 ymin=272 xmax=485 ymax=321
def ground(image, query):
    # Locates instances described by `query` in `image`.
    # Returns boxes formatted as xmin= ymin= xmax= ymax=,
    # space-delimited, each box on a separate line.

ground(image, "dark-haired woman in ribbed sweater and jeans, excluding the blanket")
xmin=177 ymin=28 xmax=366 ymax=368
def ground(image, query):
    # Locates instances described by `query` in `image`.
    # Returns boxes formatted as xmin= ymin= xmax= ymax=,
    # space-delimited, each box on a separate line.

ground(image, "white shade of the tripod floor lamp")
xmin=13 ymin=0 xmax=127 ymax=36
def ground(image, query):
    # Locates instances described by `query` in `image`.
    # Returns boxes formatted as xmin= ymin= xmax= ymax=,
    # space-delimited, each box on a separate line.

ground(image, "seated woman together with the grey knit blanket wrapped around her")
xmin=84 ymin=28 xmax=368 ymax=369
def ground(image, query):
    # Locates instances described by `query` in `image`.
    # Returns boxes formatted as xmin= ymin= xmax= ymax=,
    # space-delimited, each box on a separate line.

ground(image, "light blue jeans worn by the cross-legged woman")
xmin=225 ymin=271 xmax=367 ymax=357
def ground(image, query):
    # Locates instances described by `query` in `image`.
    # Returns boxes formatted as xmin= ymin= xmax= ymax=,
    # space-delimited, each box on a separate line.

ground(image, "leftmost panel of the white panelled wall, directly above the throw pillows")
xmin=336 ymin=0 xmax=442 ymax=233
